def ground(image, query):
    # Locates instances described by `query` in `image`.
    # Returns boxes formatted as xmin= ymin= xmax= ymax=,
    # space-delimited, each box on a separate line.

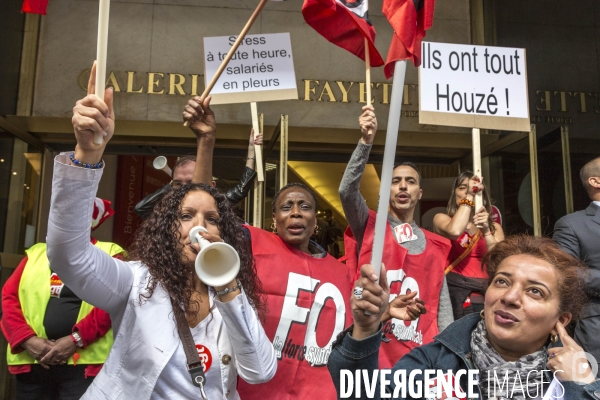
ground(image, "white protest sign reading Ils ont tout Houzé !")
xmin=419 ymin=42 xmax=530 ymax=131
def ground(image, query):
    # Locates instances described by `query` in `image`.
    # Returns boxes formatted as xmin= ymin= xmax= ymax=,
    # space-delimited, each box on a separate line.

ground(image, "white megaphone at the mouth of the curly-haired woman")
xmin=190 ymin=226 xmax=240 ymax=287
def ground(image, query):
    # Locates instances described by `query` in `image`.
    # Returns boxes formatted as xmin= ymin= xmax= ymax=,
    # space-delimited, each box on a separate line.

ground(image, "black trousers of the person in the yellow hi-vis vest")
xmin=15 ymin=364 xmax=94 ymax=400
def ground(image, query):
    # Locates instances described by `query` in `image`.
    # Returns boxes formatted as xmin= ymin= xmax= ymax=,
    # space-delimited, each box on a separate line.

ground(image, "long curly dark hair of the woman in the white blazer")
xmin=130 ymin=183 xmax=266 ymax=319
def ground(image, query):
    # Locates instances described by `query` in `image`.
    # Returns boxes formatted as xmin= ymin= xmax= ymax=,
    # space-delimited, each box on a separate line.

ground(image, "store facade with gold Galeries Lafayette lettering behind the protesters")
xmin=0 ymin=0 xmax=600 ymax=393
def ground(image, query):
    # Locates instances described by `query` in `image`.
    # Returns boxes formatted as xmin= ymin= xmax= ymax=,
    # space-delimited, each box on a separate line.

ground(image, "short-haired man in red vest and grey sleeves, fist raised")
xmin=339 ymin=106 xmax=453 ymax=368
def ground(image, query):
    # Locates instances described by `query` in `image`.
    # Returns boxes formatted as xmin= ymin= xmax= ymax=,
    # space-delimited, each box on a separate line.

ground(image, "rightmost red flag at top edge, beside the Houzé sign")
xmin=382 ymin=0 xmax=435 ymax=79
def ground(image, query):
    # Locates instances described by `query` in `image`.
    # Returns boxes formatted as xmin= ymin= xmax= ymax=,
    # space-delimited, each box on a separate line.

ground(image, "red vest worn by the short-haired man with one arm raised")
xmin=344 ymin=211 xmax=450 ymax=368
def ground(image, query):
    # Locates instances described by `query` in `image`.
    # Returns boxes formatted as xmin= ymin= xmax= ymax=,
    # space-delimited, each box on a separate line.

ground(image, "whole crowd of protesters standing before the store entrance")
xmin=1 ymin=70 xmax=600 ymax=399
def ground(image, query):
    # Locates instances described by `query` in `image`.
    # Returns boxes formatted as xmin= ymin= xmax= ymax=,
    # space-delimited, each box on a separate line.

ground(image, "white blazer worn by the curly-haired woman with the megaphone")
xmin=47 ymin=154 xmax=277 ymax=399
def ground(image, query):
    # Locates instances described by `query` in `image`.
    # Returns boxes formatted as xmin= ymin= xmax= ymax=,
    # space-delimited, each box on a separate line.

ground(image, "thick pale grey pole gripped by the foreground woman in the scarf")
xmin=371 ymin=60 xmax=406 ymax=282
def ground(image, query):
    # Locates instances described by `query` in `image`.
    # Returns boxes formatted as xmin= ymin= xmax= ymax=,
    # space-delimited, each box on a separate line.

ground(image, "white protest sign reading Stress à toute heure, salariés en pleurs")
xmin=204 ymin=33 xmax=298 ymax=104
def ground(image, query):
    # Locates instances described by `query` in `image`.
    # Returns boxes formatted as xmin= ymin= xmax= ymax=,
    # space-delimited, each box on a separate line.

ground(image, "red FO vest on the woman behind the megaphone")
xmin=238 ymin=226 xmax=354 ymax=400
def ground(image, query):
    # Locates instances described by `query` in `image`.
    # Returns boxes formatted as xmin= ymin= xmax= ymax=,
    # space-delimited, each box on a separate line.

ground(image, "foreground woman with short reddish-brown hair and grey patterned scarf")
xmin=328 ymin=236 xmax=600 ymax=399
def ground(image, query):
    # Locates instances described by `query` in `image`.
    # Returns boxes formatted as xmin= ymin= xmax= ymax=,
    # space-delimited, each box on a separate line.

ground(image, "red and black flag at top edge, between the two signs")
xmin=302 ymin=0 xmax=383 ymax=67
